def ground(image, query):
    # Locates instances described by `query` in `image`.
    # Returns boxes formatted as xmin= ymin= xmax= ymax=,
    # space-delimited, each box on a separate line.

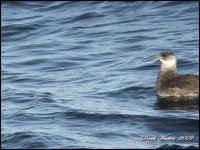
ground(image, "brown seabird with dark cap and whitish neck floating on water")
xmin=155 ymin=52 xmax=199 ymax=98
